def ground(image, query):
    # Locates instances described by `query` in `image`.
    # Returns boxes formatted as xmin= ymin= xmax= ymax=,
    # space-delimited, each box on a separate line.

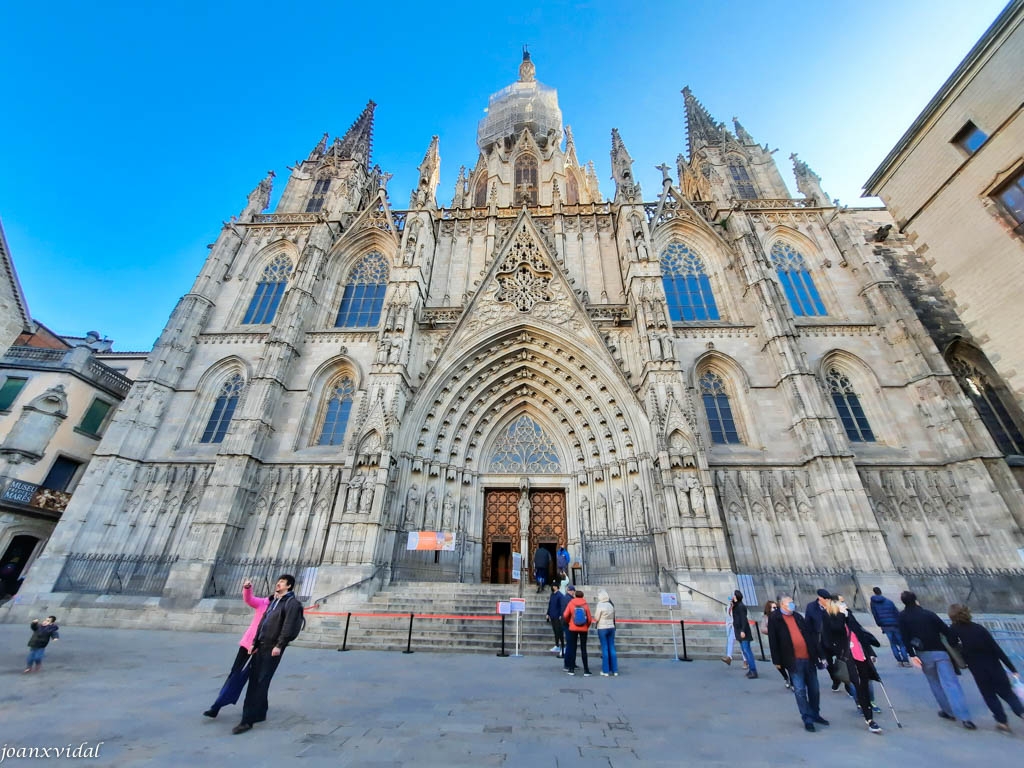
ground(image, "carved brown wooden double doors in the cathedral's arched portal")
xmin=480 ymin=488 xmax=568 ymax=584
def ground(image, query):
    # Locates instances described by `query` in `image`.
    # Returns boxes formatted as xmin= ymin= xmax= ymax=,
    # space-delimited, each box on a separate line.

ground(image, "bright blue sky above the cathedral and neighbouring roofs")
xmin=0 ymin=0 xmax=1005 ymax=350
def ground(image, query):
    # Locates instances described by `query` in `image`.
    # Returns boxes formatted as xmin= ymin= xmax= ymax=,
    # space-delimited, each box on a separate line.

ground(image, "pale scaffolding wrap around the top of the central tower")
xmin=476 ymin=80 xmax=562 ymax=150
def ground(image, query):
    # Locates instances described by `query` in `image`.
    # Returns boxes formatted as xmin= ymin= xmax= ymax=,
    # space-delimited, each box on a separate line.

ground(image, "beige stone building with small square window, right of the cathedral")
xmin=865 ymin=0 xmax=1024 ymax=481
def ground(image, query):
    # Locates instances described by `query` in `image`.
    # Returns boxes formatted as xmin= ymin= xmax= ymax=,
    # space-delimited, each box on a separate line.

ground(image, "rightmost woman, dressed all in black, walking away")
xmin=949 ymin=603 xmax=1024 ymax=732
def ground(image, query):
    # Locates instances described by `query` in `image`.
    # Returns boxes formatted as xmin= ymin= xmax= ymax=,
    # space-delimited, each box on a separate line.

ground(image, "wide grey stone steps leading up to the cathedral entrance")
xmin=297 ymin=582 xmax=737 ymax=658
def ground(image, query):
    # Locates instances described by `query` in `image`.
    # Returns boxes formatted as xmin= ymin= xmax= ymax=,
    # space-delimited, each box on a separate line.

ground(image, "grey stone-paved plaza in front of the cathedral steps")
xmin=0 ymin=625 xmax=1024 ymax=768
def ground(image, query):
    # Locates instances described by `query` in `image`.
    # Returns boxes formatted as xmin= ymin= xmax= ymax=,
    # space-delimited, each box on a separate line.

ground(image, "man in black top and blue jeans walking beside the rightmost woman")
xmin=899 ymin=591 xmax=978 ymax=731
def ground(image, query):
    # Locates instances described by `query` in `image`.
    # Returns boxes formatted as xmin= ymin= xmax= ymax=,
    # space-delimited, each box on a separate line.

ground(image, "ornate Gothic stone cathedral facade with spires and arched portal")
xmin=14 ymin=54 xmax=1024 ymax=611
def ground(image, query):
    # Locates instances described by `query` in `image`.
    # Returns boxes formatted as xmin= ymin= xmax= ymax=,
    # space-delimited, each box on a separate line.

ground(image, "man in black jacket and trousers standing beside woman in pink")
xmin=231 ymin=573 xmax=302 ymax=733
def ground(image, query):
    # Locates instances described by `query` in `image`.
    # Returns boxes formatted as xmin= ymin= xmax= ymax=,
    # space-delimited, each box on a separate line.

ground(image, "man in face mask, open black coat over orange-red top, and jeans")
xmin=768 ymin=597 xmax=828 ymax=732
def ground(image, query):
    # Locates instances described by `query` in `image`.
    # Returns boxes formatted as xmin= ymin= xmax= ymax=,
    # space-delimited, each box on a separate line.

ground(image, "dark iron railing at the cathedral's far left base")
xmin=53 ymin=553 xmax=178 ymax=597
